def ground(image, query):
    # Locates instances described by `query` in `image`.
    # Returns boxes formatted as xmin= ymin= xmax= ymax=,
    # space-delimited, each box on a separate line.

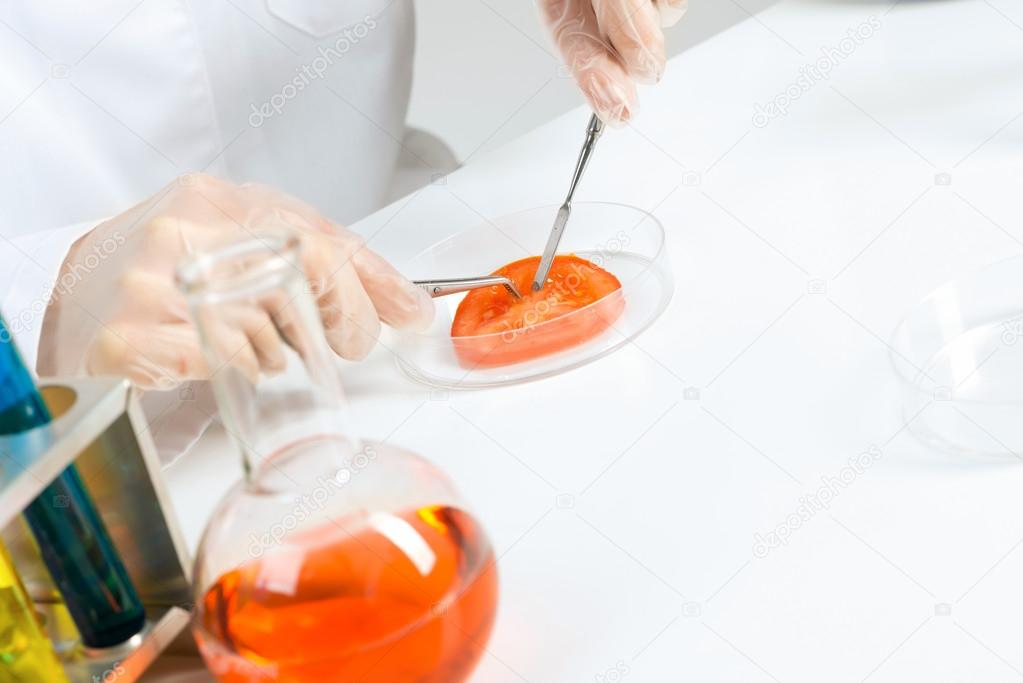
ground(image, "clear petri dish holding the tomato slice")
xmin=396 ymin=202 xmax=673 ymax=390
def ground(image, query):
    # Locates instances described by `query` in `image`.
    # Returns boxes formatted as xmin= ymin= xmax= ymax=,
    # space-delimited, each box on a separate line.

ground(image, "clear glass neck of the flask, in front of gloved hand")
xmin=178 ymin=230 xmax=359 ymax=482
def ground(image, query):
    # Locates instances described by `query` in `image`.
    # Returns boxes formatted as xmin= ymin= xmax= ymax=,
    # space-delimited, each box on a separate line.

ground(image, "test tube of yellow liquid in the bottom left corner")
xmin=0 ymin=543 xmax=68 ymax=683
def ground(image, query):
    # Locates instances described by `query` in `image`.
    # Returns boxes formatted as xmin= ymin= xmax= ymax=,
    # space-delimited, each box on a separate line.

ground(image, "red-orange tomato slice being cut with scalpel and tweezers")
xmin=451 ymin=256 xmax=625 ymax=367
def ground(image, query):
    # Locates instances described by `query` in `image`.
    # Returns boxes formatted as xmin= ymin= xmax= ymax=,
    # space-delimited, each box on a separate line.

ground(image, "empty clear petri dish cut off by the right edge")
xmin=890 ymin=257 xmax=1023 ymax=460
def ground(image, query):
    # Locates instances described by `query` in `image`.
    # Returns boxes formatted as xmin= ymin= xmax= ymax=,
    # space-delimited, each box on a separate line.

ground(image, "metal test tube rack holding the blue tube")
xmin=0 ymin=377 xmax=194 ymax=683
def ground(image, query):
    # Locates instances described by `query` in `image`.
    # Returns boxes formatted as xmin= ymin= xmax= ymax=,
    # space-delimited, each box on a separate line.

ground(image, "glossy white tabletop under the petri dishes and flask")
xmin=157 ymin=0 xmax=1023 ymax=683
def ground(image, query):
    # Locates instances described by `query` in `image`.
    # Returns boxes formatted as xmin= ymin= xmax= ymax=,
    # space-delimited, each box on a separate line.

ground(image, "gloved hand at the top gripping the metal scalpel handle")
xmin=539 ymin=0 xmax=687 ymax=126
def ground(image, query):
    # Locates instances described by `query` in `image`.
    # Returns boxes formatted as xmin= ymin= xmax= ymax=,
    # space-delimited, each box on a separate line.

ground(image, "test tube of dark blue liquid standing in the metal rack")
xmin=0 ymin=318 xmax=145 ymax=647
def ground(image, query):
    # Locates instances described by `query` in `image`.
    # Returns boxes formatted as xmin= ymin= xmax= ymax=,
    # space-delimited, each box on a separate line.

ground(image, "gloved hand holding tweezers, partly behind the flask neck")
xmin=38 ymin=174 xmax=434 ymax=390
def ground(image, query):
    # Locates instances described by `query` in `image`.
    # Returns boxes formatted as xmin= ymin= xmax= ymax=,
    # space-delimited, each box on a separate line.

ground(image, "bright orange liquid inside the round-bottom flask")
xmin=196 ymin=507 xmax=497 ymax=683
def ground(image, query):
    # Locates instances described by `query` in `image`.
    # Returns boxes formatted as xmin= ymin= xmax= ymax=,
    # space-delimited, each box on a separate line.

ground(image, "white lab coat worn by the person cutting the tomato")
xmin=0 ymin=0 xmax=414 ymax=458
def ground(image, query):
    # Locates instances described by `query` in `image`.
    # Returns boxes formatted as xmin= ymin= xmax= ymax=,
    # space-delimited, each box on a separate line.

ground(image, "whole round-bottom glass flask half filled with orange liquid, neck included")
xmin=179 ymin=226 xmax=497 ymax=683
